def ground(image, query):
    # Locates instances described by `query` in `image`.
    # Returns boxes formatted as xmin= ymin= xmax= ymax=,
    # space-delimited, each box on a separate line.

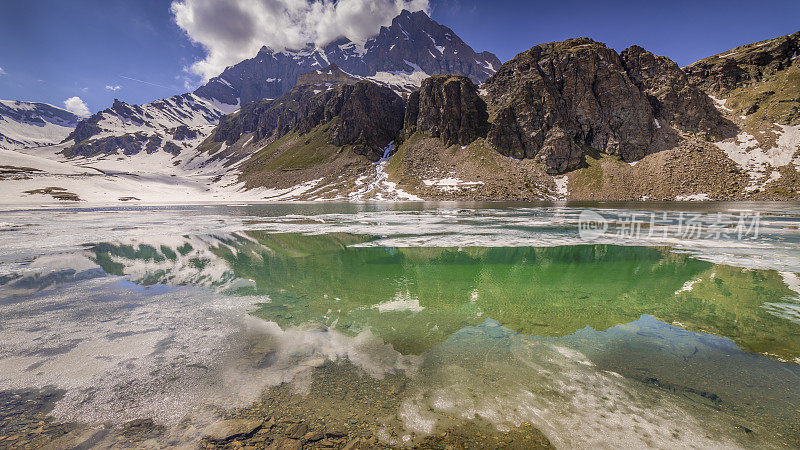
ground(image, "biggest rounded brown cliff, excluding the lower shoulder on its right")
xmin=484 ymin=38 xmax=655 ymax=173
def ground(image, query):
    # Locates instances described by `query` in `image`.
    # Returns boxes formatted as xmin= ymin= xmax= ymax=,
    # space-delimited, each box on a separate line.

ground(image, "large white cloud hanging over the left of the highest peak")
xmin=171 ymin=0 xmax=428 ymax=80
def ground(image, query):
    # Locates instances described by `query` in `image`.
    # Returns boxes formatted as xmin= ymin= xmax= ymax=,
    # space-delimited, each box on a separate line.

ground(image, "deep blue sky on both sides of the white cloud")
xmin=0 ymin=0 xmax=800 ymax=112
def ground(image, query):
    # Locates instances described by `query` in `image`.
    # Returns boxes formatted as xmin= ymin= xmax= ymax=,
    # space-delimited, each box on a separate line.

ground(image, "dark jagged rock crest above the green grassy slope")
xmin=210 ymin=66 xmax=404 ymax=160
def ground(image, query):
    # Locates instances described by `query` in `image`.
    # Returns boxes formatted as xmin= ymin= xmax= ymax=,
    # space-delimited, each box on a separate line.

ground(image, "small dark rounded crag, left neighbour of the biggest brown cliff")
xmin=403 ymin=75 xmax=489 ymax=146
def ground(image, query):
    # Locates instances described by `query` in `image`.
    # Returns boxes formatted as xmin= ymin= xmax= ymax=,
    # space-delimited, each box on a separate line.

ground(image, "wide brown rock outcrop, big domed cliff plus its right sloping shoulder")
xmin=484 ymin=38 xmax=735 ymax=174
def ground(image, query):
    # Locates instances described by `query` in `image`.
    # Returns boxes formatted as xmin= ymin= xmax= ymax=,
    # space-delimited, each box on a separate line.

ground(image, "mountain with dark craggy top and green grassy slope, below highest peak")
xmin=191 ymin=65 xmax=405 ymax=198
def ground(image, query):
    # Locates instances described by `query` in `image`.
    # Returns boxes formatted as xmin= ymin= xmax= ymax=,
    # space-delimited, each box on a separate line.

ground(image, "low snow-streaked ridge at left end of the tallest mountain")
xmin=63 ymin=94 xmax=231 ymax=157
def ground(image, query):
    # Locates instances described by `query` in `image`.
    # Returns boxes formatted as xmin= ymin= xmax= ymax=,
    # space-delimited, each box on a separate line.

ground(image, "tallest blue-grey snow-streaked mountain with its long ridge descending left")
xmin=51 ymin=11 xmax=500 ymax=165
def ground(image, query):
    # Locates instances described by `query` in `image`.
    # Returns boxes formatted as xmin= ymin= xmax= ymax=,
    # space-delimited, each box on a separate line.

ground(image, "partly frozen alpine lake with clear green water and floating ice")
xmin=0 ymin=204 xmax=800 ymax=447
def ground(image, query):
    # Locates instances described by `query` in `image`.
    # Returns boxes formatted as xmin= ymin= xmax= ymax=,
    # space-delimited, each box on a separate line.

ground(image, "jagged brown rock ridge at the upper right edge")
xmin=684 ymin=32 xmax=800 ymax=97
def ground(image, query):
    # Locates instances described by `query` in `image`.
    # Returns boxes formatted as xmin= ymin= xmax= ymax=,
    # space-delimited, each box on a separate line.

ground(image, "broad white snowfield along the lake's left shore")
xmin=0 ymin=144 xmax=270 ymax=205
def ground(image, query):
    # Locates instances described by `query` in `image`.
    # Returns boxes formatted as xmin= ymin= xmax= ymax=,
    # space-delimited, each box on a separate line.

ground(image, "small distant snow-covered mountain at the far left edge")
xmin=0 ymin=100 xmax=82 ymax=149
